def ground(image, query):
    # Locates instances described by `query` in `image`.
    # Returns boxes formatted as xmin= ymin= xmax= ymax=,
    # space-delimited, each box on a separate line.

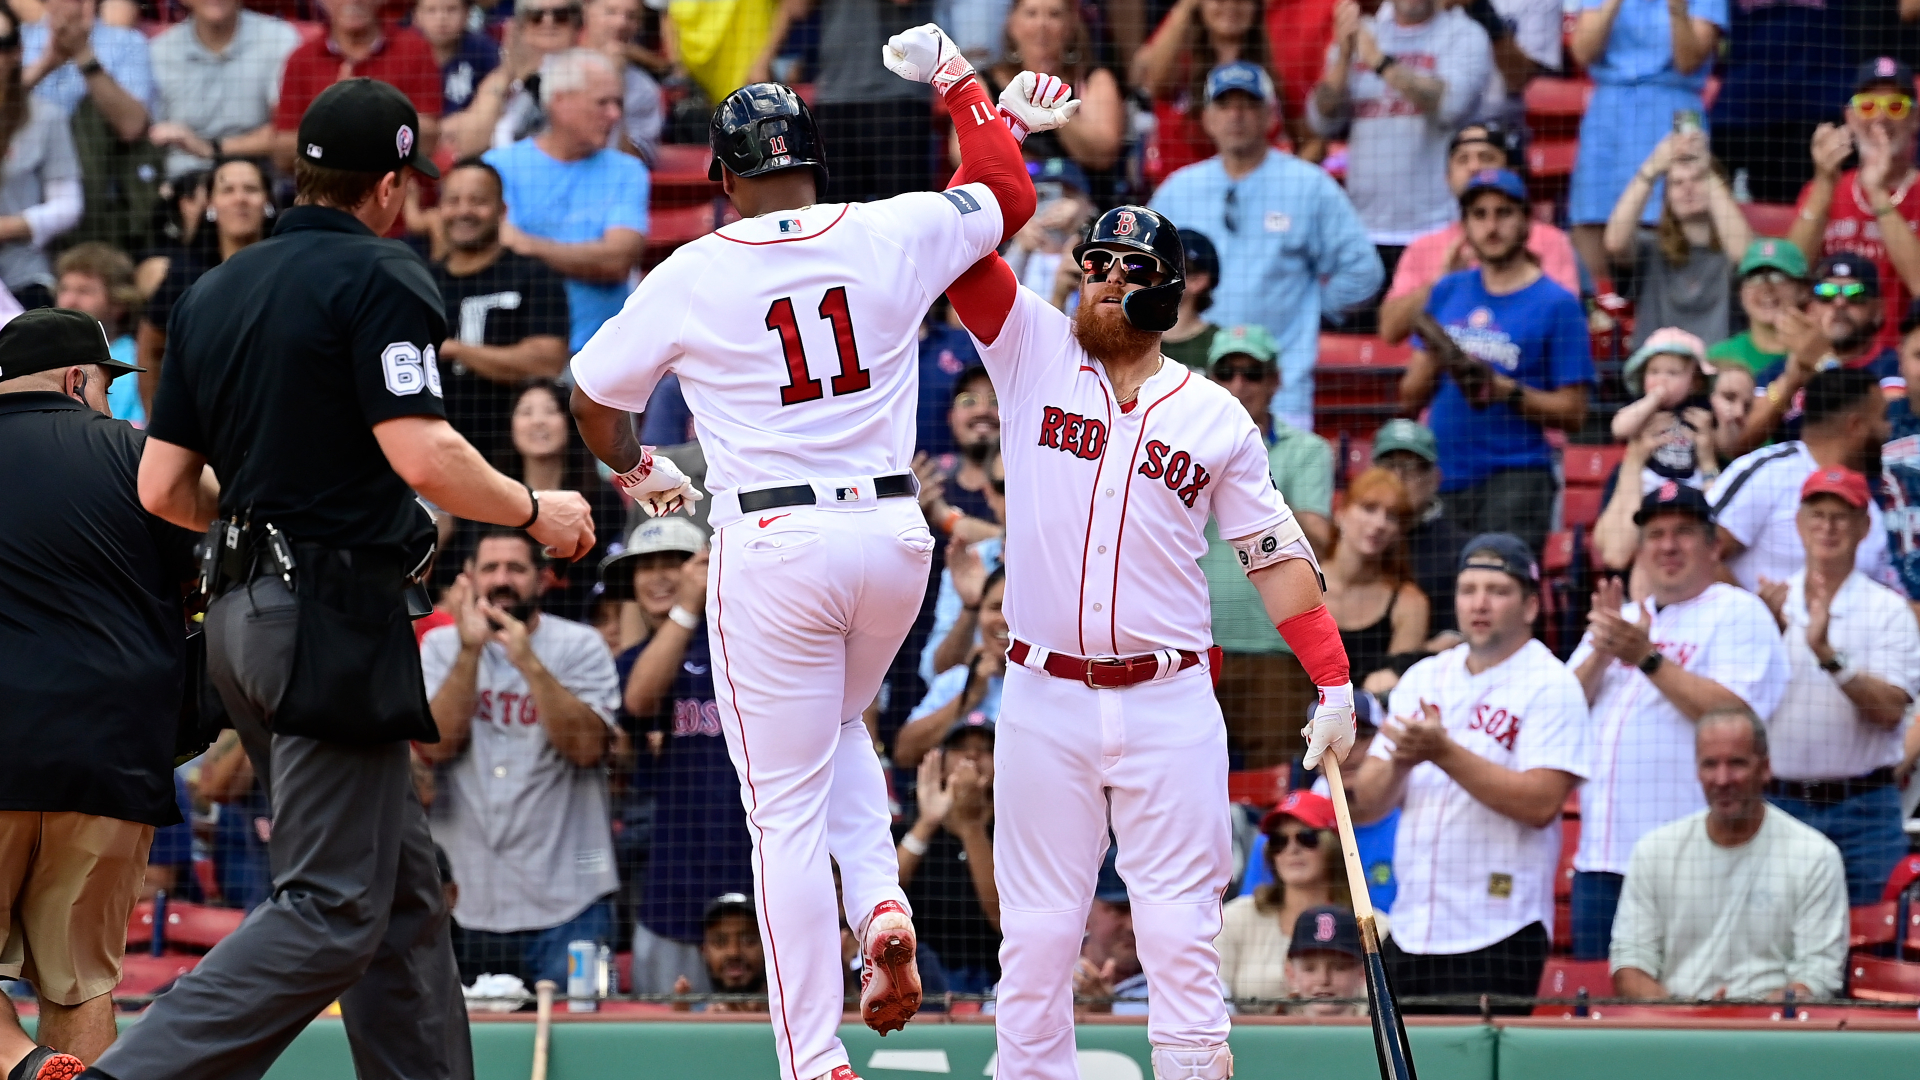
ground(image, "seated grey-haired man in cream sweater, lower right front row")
xmin=1607 ymin=705 xmax=1847 ymax=1001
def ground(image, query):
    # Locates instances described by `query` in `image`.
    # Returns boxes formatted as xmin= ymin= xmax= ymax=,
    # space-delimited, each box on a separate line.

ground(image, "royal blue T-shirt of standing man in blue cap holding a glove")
xmin=1415 ymin=269 xmax=1594 ymax=492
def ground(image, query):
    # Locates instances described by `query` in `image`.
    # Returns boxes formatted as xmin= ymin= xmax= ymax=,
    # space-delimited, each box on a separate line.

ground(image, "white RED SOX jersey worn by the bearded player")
xmin=975 ymin=288 xmax=1292 ymax=657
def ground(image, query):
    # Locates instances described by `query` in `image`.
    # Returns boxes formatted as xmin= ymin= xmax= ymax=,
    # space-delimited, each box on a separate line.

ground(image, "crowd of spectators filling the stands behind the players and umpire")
xmin=0 ymin=0 xmax=1920 ymax=1045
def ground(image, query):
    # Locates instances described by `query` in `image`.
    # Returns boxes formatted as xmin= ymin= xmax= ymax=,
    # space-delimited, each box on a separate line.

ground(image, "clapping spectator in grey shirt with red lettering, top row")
xmin=1308 ymin=0 xmax=1494 ymax=282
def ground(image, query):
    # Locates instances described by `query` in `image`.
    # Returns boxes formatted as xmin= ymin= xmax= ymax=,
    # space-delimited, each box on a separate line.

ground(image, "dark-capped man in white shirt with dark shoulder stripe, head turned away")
xmin=1713 ymin=369 xmax=1887 ymax=590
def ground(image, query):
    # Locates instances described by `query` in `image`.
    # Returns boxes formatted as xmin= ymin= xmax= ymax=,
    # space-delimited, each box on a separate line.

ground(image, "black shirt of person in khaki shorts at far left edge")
xmin=0 ymin=392 xmax=198 ymax=826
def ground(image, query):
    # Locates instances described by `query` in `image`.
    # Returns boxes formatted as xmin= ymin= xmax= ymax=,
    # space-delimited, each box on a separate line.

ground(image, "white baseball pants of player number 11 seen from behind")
xmin=707 ymin=498 xmax=933 ymax=1080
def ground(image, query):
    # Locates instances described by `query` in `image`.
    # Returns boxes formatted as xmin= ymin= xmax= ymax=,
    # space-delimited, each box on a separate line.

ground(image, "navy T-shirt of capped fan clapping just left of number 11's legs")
xmin=614 ymin=625 xmax=753 ymax=944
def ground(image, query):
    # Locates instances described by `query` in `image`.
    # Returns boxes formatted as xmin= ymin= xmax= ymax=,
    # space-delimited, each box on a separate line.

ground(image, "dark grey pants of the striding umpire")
xmin=96 ymin=578 xmax=474 ymax=1080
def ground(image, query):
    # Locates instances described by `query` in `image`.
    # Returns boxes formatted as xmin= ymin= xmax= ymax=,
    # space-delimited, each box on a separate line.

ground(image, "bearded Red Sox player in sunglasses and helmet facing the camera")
xmin=947 ymin=206 xmax=1354 ymax=1080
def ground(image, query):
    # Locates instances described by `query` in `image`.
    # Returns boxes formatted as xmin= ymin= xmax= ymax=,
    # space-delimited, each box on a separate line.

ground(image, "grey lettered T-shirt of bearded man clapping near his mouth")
xmin=420 ymin=613 xmax=620 ymax=932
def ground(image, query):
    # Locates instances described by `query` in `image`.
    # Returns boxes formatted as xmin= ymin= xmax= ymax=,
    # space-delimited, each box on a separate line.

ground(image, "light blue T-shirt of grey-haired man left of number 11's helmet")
xmin=482 ymin=138 xmax=653 ymax=352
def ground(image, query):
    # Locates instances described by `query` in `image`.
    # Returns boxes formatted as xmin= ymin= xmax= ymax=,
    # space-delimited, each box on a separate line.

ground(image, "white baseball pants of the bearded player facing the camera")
xmin=993 ymin=665 xmax=1233 ymax=1080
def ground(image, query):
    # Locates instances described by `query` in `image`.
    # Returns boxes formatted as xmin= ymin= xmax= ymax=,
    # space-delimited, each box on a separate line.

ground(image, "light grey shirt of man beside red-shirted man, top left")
xmin=148 ymin=12 xmax=300 ymax=177
